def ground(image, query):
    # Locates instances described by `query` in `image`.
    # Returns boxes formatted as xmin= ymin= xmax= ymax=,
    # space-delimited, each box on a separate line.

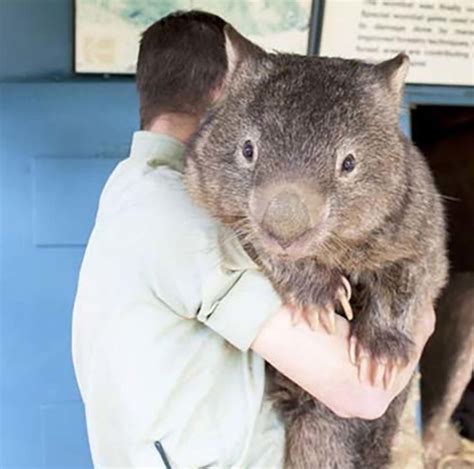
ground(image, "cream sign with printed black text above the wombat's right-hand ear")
xmin=314 ymin=0 xmax=474 ymax=86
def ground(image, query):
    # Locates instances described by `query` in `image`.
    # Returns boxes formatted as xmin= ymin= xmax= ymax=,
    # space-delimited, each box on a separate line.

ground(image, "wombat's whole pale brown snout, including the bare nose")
xmin=250 ymin=185 xmax=323 ymax=248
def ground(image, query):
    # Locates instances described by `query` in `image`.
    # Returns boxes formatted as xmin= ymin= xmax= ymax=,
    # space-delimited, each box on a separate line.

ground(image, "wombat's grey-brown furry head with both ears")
xmin=186 ymin=27 xmax=408 ymax=259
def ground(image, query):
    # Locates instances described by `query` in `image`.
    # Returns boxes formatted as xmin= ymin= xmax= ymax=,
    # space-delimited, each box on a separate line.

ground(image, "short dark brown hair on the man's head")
xmin=136 ymin=10 xmax=227 ymax=128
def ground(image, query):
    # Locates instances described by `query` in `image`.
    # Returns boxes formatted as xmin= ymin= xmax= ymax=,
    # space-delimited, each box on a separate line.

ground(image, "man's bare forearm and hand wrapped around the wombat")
xmin=251 ymin=307 xmax=435 ymax=419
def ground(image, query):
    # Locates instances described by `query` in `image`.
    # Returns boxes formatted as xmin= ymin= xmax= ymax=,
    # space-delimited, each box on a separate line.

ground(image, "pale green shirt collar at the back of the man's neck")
xmin=130 ymin=130 xmax=186 ymax=172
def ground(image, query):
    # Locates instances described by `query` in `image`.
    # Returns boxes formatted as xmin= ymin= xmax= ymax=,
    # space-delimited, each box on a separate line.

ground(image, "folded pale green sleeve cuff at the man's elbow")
xmin=197 ymin=270 xmax=281 ymax=352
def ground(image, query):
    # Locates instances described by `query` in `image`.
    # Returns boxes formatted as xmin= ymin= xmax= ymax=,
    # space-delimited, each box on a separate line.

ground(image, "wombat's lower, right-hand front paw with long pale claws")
xmin=349 ymin=323 xmax=413 ymax=389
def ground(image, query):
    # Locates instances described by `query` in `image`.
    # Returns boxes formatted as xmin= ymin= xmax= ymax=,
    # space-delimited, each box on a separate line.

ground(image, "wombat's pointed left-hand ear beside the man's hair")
xmin=218 ymin=24 xmax=267 ymax=101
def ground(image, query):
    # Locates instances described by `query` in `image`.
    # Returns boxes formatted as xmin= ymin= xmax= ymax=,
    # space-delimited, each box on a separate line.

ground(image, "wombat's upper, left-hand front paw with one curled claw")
xmin=289 ymin=276 xmax=353 ymax=334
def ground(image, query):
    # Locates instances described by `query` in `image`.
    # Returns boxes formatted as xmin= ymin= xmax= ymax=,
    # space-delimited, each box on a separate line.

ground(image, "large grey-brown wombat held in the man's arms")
xmin=185 ymin=26 xmax=447 ymax=469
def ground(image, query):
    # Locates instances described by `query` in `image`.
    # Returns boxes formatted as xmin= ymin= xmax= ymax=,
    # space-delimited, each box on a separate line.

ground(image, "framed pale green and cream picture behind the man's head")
xmin=75 ymin=0 xmax=313 ymax=74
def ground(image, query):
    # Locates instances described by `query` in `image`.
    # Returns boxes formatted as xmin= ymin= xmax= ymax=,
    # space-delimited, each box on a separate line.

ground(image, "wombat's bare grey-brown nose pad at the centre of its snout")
xmin=262 ymin=189 xmax=311 ymax=246
